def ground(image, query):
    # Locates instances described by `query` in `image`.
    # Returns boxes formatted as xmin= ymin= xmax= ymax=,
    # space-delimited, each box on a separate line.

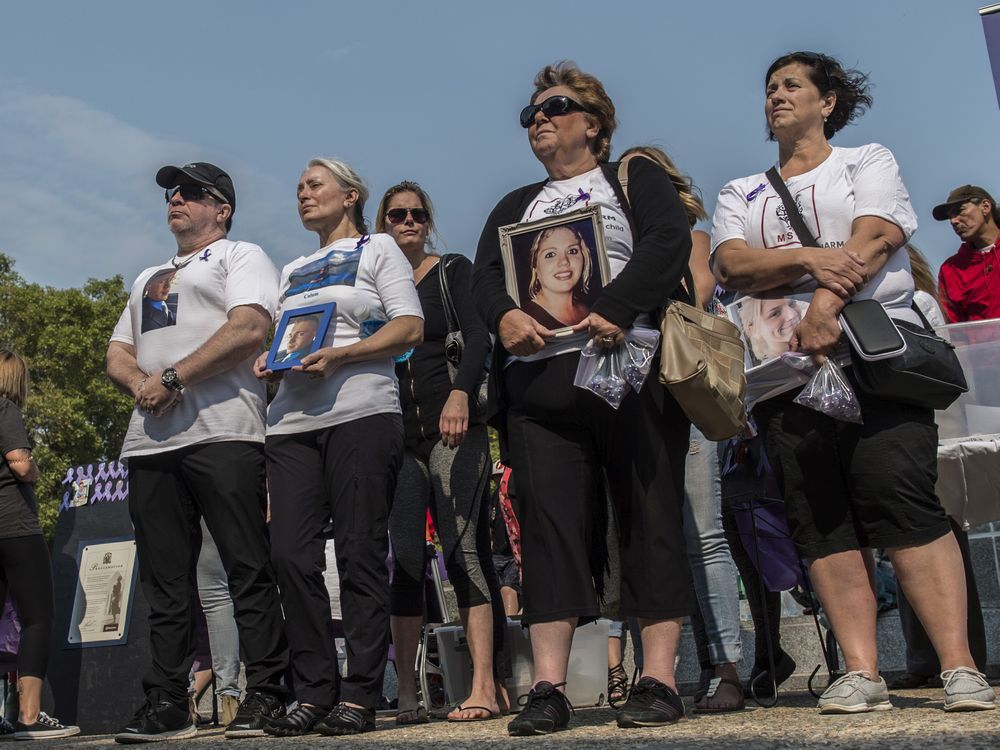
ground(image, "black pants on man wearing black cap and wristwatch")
xmin=128 ymin=442 xmax=288 ymax=705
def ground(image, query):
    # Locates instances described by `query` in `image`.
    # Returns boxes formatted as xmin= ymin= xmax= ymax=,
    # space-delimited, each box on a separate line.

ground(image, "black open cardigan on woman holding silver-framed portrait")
xmin=472 ymin=159 xmax=691 ymax=350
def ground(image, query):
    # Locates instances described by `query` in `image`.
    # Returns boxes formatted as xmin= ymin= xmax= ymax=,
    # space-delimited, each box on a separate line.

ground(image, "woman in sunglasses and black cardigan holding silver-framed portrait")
xmin=473 ymin=63 xmax=693 ymax=735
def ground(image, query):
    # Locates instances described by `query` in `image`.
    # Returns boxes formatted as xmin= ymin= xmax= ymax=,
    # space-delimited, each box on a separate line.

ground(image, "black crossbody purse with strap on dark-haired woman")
xmin=767 ymin=167 xmax=969 ymax=410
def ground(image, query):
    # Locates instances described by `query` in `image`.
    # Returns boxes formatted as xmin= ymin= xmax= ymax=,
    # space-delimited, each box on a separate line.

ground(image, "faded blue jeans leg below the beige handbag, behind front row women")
xmin=684 ymin=427 xmax=742 ymax=664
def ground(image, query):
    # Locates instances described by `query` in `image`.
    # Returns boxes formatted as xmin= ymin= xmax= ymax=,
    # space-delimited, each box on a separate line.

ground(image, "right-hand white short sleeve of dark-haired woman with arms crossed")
xmin=853 ymin=143 xmax=917 ymax=239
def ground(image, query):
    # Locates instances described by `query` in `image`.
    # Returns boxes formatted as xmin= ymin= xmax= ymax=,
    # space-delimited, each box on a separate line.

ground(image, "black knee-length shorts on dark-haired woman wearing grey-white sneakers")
xmin=753 ymin=378 xmax=951 ymax=559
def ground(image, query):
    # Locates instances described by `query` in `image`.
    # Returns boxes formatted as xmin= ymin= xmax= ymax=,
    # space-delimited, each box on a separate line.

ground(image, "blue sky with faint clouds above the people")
xmin=0 ymin=0 xmax=1000 ymax=286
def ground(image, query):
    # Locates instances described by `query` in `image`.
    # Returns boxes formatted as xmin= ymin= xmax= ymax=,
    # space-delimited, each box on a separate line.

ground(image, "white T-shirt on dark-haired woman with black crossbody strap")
xmin=711 ymin=143 xmax=920 ymax=323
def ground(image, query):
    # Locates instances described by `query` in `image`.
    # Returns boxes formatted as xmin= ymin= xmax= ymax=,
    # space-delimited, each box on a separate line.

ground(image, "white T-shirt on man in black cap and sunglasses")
xmin=111 ymin=239 xmax=278 ymax=458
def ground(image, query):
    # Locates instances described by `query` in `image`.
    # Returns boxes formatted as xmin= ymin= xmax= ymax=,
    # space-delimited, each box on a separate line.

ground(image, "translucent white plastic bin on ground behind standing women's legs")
xmin=434 ymin=619 xmax=611 ymax=712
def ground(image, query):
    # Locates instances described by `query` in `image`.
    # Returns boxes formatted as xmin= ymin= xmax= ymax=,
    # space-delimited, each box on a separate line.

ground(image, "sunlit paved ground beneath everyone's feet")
xmin=15 ymin=690 xmax=1000 ymax=750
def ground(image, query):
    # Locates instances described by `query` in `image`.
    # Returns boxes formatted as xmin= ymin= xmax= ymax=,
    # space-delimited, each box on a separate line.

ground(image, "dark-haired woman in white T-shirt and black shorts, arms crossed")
xmin=712 ymin=52 xmax=996 ymax=713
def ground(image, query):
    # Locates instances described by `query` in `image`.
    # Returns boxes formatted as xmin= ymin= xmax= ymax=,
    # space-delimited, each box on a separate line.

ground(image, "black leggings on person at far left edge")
xmin=0 ymin=534 xmax=54 ymax=679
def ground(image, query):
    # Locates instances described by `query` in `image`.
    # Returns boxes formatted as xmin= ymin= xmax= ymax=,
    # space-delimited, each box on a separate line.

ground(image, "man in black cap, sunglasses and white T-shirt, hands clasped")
xmin=107 ymin=162 xmax=288 ymax=742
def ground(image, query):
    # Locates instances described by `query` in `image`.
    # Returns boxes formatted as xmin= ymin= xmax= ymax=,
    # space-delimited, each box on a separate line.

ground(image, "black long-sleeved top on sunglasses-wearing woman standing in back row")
xmin=396 ymin=255 xmax=490 ymax=446
